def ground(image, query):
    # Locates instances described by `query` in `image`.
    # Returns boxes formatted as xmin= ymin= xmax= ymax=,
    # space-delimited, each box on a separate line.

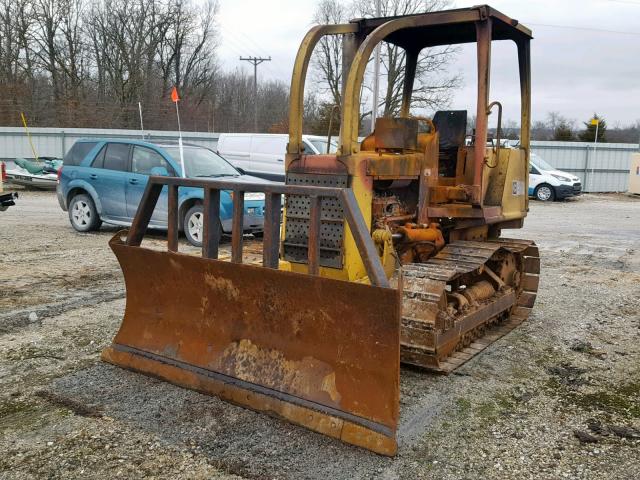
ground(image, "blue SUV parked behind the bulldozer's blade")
xmin=56 ymin=139 xmax=269 ymax=246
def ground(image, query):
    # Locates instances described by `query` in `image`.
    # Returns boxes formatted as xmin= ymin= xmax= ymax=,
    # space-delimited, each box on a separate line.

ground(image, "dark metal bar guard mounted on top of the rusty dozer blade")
xmin=126 ymin=176 xmax=390 ymax=288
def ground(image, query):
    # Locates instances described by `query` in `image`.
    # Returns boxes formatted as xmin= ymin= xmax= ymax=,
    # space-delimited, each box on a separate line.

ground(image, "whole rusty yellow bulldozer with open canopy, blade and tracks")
xmin=102 ymin=6 xmax=540 ymax=456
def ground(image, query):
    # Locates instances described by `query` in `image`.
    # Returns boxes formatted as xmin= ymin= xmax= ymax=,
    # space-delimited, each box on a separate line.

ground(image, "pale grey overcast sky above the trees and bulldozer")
xmin=218 ymin=0 xmax=640 ymax=126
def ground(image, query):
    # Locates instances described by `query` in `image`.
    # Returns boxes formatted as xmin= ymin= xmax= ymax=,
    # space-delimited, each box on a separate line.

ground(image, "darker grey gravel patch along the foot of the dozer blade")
xmin=48 ymin=363 xmax=451 ymax=480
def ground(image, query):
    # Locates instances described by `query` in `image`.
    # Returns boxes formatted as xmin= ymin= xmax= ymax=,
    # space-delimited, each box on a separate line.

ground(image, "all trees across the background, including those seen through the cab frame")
xmin=0 ymin=0 xmax=640 ymax=143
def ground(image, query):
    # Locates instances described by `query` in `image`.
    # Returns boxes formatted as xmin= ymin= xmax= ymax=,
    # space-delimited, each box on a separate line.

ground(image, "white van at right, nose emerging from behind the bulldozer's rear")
xmin=529 ymin=153 xmax=582 ymax=202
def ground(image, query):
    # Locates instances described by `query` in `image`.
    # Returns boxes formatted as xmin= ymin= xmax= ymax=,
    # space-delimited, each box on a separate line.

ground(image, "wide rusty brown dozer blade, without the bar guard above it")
xmin=102 ymin=233 xmax=401 ymax=455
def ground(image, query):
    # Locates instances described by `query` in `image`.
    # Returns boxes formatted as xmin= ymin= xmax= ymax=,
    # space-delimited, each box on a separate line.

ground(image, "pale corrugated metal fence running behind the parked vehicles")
xmin=0 ymin=127 xmax=638 ymax=192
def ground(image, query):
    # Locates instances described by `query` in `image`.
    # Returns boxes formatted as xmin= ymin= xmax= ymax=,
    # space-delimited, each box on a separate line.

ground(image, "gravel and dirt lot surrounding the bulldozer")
xmin=0 ymin=192 xmax=640 ymax=480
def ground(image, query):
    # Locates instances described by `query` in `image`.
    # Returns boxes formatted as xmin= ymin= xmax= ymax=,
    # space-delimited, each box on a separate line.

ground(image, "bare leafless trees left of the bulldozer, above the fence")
xmin=0 ymin=0 xmax=288 ymax=131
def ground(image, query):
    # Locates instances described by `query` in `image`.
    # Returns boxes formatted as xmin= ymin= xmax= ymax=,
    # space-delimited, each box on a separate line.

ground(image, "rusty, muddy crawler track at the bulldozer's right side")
xmin=401 ymin=239 xmax=540 ymax=373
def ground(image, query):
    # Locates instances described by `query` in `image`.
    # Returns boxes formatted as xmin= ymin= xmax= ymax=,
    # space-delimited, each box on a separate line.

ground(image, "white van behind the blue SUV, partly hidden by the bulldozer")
xmin=217 ymin=133 xmax=338 ymax=181
